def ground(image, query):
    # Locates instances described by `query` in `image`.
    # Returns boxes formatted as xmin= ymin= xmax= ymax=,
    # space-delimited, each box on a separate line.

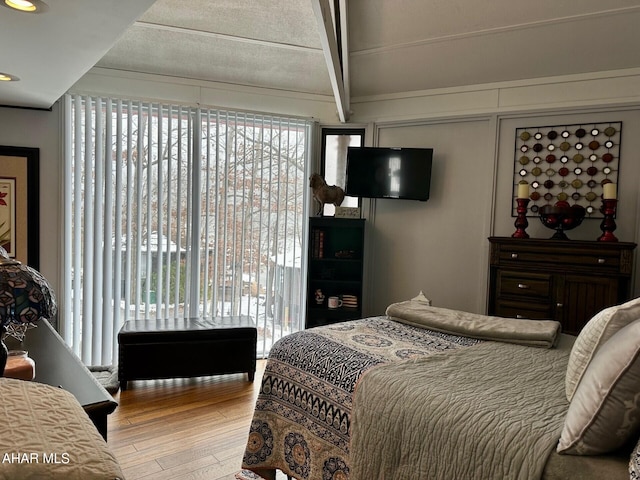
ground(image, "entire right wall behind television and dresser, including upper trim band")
xmin=351 ymin=69 xmax=640 ymax=314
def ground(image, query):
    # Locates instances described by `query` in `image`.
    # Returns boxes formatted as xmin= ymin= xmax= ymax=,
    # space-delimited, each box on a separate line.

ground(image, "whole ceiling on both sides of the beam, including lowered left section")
xmin=0 ymin=0 xmax=640 ymax=108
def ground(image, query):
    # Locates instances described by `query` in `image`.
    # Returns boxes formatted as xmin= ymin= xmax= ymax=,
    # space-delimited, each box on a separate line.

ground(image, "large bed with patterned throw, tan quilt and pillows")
xmin=238 ymin=296 xmax=640 ymax=480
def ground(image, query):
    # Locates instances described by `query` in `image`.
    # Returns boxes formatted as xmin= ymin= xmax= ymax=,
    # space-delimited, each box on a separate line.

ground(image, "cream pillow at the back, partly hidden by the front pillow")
xmin=565 ymin=297 xmax=640 ymax=401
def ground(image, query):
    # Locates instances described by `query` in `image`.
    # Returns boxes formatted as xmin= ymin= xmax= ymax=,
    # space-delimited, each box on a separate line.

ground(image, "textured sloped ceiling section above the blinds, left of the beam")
xmin=98 ymin=0 xmax=331 ymax=95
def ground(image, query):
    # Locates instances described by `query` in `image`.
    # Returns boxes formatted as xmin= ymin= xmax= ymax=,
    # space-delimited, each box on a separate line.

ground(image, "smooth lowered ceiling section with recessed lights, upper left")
xmin=0 ymin=0 xmax=153 ymax=108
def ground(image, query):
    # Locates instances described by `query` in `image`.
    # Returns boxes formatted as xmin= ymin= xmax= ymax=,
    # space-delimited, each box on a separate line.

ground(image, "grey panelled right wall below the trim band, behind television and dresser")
xmin=366 ymin=108 xmax=640 ymax=314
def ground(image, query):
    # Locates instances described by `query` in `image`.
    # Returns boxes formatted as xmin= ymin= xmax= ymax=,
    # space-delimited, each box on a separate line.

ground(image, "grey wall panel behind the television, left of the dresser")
xmin=368 ymin=118 xmax=495 ymax=314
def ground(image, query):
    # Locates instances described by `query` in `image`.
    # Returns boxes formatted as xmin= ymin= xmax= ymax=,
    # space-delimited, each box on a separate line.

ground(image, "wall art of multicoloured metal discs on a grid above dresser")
xmin=511 ymin=122 xmax=622 ymax=218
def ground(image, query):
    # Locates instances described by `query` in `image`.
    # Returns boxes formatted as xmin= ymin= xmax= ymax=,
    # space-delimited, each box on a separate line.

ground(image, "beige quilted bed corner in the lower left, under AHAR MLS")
xmin=0 ymin=377 xmax=124 ymax=480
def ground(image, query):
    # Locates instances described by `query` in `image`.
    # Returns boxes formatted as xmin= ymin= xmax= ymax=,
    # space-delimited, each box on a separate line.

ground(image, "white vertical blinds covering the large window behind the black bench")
xmin=61 ymin=95 xmax=313 ymax=365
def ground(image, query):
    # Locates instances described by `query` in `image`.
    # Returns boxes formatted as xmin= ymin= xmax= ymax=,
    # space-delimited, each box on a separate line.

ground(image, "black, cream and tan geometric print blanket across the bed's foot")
xmin=242 ymin=316 xmax=481 ymax=480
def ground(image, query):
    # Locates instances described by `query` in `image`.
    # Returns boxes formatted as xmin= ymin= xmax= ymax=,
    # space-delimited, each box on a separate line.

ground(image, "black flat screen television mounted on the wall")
xmin=345 ymin=147 xmax=433 ymax=201
